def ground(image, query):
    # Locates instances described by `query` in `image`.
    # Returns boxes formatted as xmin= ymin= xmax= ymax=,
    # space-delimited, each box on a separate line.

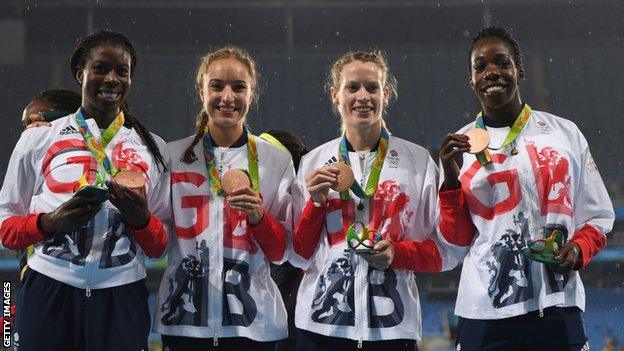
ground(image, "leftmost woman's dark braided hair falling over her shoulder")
xmin=69 ymin=29 xmax=167 ymax=171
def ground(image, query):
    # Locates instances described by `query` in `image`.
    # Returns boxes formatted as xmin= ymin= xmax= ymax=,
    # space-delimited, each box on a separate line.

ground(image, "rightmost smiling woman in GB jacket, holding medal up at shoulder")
xmin=439 ymin=27 xmax=614 ymax=350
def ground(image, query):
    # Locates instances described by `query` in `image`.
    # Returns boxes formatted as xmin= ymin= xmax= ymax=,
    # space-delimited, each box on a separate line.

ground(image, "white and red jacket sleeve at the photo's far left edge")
xmin=0 ymin=130 xmax=47 ymax=250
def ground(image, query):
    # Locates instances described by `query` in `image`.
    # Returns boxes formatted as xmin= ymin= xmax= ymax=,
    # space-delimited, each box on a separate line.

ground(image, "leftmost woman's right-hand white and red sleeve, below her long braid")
xmin=130 ymin=136 xmax=173 ymax=258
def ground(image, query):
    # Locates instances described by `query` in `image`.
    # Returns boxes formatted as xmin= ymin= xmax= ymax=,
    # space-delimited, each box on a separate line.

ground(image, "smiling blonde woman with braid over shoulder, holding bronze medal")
xmin=154 ymin=47 xmax=295 ymax=351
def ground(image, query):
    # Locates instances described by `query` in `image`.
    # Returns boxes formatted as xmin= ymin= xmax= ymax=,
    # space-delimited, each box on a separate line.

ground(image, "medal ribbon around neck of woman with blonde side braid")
xmin=203 ymin=126 xmax=260 ymax=196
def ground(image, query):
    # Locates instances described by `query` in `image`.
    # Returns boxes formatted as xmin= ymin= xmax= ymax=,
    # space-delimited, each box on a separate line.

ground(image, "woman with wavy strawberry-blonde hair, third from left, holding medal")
xmin=290 ymin=52 xmax=456 ymax=351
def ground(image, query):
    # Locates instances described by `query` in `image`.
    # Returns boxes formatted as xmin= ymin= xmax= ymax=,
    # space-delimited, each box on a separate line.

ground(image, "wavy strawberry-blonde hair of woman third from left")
xmin=326 ymin=50 xmax=399 ymax=134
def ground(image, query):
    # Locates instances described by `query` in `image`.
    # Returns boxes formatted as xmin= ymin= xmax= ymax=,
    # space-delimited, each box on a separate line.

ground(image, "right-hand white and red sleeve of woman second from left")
xmin=252 ymin=151 xmax=295 ymax=264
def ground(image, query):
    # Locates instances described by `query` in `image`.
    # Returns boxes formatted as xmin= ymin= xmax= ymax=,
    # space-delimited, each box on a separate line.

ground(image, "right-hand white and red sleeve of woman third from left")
xmin=390 ymin=155 xmax=457 ymax=272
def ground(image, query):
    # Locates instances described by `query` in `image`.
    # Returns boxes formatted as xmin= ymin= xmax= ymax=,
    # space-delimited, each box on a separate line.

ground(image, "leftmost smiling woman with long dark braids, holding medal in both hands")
xmin=0 ymin=31 xmax=169 ymax=350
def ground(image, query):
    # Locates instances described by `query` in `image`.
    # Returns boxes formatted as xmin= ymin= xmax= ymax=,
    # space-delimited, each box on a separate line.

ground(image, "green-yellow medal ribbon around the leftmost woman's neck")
xmin=74 ymin=108 xmax=125 ymax=177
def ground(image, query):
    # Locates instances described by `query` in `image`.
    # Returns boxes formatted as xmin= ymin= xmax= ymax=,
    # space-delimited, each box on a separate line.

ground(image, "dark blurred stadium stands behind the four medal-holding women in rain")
xmin=0 ymin=0 xmax=624 ymax=350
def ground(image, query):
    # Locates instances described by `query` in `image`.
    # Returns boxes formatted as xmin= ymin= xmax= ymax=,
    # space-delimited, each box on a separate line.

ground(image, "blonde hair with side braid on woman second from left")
xmin=182 ymin=46 xmax=260 ymax=163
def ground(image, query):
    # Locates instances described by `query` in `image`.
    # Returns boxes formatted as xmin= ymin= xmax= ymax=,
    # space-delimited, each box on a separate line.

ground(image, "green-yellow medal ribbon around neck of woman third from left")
xmin=338 ymin=127 xmax=390 ymax=200
